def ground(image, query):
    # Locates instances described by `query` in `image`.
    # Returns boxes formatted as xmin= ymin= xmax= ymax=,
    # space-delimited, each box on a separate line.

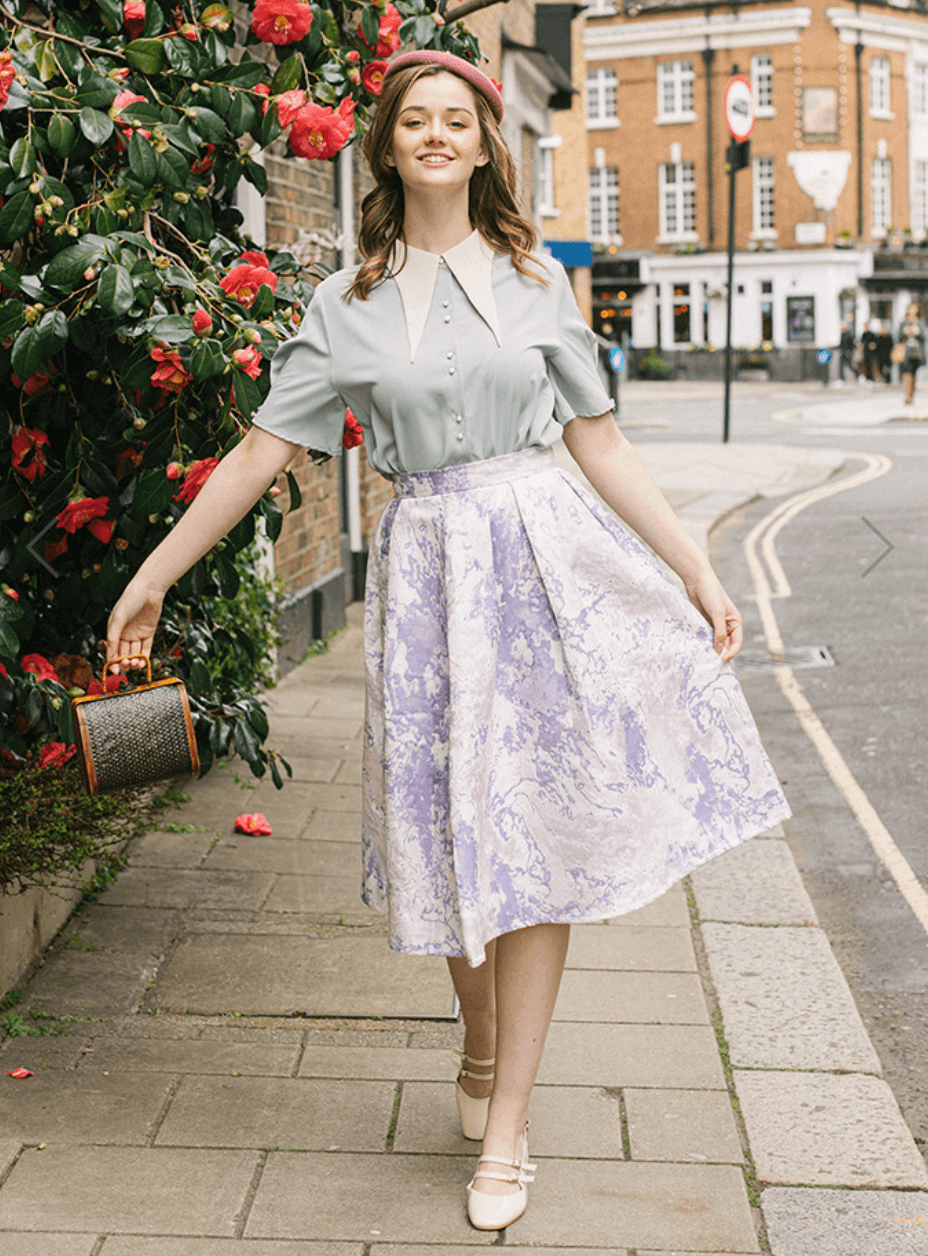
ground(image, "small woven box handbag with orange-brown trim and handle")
xmin=70 ymin=654 xmax=200 ymax=794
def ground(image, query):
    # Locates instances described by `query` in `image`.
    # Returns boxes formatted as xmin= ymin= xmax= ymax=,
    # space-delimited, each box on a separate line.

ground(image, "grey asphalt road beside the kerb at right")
xmin=622 ymin=384 xmax=928 ymax=1154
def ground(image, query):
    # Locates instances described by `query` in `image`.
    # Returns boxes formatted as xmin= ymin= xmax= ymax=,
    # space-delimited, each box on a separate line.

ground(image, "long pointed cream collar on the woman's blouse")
xmin=391 ymin=231 xmax=502 ymax=362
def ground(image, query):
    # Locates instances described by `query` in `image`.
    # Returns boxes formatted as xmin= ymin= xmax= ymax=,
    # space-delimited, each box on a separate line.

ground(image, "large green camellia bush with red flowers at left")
xmin=0 ymin=0 xmax=486 ymax=803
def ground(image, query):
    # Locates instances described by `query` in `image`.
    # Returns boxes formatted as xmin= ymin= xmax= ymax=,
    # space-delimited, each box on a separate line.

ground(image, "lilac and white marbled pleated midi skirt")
xmin=362 ymin=448 xmax=790 ymax=965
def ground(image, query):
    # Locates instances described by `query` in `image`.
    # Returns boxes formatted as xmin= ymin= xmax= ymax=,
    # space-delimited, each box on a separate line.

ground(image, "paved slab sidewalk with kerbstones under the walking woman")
xmin=0 ymin=446 xmax=928 ymax=1256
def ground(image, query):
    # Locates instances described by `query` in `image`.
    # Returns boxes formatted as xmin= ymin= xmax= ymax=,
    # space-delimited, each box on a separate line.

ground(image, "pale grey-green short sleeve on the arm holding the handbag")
xmin=252 ymin=282 xmax=345 ymax=456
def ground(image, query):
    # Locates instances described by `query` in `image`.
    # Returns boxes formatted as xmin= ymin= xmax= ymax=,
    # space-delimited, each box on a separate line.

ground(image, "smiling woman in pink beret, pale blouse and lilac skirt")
xmin=108 ymin=51 xmax=789 ymax=1230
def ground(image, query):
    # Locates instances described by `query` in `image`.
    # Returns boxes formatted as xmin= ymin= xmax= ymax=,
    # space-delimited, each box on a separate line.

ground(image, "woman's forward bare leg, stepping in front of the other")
xmin=475 ymin=924 xmax=570 ymax=1194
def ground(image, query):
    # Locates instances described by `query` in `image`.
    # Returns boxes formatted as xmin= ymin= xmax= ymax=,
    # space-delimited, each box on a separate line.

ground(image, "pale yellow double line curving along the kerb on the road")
xmin=743 ymin=453 xmax=928 ymax=933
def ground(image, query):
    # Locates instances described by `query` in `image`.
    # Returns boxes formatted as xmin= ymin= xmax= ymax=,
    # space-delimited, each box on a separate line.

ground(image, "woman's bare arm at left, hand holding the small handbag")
xmin=107 ymin=427 xmax=303 ymax=669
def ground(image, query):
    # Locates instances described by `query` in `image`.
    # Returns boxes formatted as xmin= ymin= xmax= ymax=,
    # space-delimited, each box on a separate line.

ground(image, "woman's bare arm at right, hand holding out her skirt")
xmin=564 ymin=412 xmax=743 ymax=662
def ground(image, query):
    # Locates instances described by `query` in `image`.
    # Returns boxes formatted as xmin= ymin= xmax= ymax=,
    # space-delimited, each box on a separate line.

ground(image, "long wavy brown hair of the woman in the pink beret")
xmin=345 ymin=63 xmax=548 ymax=300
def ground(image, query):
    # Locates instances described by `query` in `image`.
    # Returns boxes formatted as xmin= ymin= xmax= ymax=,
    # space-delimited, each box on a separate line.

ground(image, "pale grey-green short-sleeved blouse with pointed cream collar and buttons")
xmin=254 ymin=231 xmax=613 ymax=476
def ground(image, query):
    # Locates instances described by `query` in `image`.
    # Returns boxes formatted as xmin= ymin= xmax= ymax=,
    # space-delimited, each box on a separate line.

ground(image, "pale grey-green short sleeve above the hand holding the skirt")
xmin=546 ymin=261 xmax=614 ymax=423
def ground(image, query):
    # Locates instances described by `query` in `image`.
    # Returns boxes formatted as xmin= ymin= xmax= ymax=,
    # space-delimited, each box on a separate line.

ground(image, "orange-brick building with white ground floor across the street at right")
xmin=555 ymin=0 xmax=928 ymax=373
